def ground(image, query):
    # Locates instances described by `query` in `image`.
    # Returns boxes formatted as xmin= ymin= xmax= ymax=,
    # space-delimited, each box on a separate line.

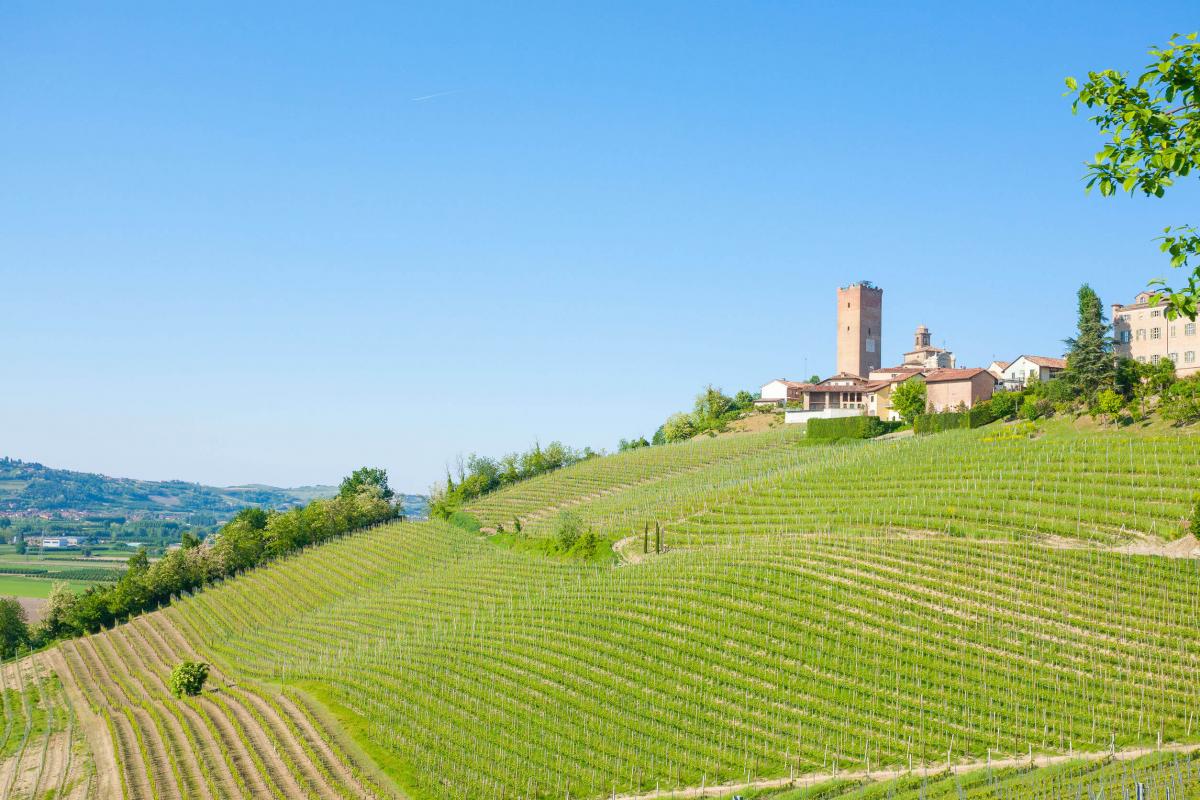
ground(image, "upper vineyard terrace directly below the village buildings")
xmin=493 ymin=426 xmax=1200 ymax=547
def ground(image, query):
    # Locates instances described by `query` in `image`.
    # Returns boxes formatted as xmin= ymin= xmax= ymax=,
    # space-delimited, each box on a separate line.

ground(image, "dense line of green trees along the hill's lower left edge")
xmin=0 ymin=467 xmax=400 ymax=658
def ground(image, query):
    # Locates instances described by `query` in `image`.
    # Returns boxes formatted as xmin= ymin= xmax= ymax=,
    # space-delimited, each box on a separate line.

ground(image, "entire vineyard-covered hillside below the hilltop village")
xmin=16 ymin=423 xmax=1200 ymax=799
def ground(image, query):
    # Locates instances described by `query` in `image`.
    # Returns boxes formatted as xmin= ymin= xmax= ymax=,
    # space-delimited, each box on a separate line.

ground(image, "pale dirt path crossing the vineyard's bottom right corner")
xmin=611 ymin=744 xmax=1200 ymax=800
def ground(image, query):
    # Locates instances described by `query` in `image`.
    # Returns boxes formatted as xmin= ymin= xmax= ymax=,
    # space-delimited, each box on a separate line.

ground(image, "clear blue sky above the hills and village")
xmin=0 ymin=0 xmax=1200 ymax=491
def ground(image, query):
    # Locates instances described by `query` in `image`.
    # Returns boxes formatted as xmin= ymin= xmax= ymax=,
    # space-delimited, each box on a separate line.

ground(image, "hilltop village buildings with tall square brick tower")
xmin=756 ymin=281 xmax=1070 ymax=423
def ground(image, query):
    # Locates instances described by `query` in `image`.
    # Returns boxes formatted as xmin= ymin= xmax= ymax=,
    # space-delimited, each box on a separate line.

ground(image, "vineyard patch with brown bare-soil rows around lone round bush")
xmin=49 ymin=614 xmax=391 ymax=800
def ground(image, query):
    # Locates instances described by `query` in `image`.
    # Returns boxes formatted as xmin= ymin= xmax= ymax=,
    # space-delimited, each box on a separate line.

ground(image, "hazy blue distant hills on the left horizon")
xmin=0 ymin=458 xmax=425 ymax=521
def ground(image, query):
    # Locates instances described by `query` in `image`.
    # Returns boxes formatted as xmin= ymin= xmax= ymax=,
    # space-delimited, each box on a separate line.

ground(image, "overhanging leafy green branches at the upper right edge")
xmin=1067 ymin=34 xmax=1200 ymax=320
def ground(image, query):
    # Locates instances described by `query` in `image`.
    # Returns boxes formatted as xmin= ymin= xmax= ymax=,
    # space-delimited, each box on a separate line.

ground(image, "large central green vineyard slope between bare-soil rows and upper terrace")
xmin=167 ymin=524 xmax=1200 ymax=798
